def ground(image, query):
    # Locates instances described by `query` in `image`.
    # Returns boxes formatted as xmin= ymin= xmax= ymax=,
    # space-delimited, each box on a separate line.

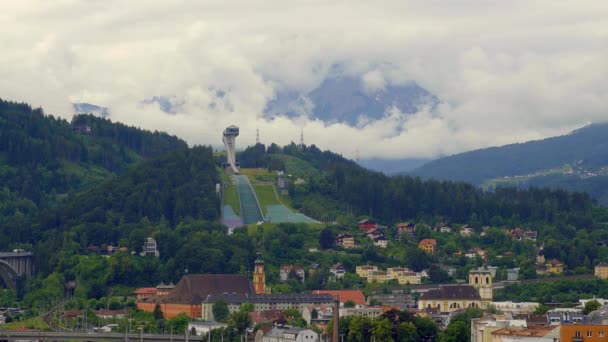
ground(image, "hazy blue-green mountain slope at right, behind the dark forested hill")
xmin=411 ymin=124 xmax=608 ymax=205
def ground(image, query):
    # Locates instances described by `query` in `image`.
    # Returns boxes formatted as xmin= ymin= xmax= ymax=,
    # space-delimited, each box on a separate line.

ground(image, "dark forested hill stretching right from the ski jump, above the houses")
xmin=238 ymin=144 xmax=593 ymax=228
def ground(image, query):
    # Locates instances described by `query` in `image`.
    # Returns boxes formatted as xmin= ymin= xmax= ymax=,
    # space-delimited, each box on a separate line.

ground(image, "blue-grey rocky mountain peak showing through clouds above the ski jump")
xmin=265 ymin=76 xmax=440 ymax=126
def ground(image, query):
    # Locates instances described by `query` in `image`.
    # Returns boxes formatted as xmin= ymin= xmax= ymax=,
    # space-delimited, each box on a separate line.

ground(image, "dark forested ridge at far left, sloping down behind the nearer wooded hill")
xmin=0 ymin=99 xmax=187 ymax=232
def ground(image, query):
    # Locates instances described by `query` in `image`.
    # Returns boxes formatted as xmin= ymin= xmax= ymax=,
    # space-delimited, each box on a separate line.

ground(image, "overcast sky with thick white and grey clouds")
xmin=0 ymin=0 xmax=608 ymax=159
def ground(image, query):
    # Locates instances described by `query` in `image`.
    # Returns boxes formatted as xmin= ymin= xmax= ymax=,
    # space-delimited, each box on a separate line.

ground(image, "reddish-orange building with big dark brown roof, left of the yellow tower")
xmin=137 ymin=274 xmax=254 ymax=319
